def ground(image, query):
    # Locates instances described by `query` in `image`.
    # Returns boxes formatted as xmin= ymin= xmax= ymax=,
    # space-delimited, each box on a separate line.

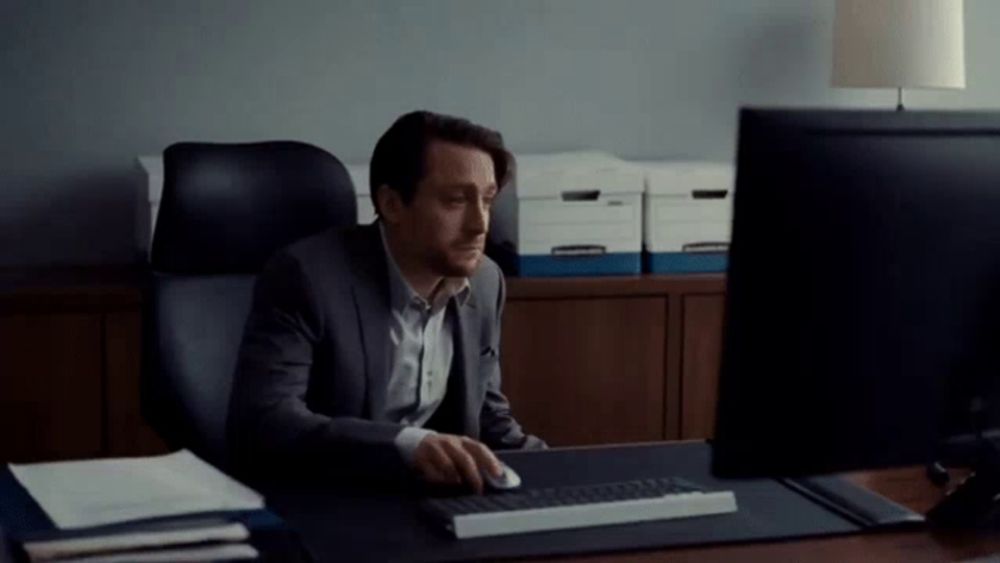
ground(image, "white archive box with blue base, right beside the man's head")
xmin=491 ymin=151 xmax=643 ymax=276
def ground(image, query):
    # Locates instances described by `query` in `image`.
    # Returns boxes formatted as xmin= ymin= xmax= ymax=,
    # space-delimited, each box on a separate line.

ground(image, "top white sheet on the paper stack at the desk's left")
xmin=10 ymin=450 xmax=264 ymax=529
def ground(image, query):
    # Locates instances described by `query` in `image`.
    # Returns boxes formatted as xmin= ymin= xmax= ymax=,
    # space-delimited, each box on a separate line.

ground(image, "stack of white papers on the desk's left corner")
xmin=10 ymin=450 xmax=264 ymax=562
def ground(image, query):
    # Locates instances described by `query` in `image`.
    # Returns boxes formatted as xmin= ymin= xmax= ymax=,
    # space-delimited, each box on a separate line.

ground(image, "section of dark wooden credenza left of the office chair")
xmin=0 ymin=267 xmax=166 ymax=462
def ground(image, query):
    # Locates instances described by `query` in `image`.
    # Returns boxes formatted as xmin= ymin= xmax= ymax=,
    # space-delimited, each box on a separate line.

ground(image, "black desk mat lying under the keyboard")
xmin=265 ymin=443 xmax=916 ymax=561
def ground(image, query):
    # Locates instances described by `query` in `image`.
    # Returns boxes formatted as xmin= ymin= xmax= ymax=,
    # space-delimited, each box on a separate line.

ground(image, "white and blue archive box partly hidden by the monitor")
xmin=638 ymin=161 xmax=736 ymax=273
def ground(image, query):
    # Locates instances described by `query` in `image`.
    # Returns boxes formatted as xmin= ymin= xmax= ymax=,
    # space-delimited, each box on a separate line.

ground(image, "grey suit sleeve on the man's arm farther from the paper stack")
xmin=479 ymin=268 xmax=547 ymax=450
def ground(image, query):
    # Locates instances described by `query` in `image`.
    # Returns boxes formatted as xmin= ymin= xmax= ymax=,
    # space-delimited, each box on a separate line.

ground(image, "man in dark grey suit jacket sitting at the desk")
xmin=228 ymin=112 xmax=544 ymax=491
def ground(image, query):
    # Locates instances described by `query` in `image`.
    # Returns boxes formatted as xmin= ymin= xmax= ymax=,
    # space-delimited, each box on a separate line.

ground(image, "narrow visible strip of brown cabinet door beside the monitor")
xmin=681 ymin=294 xmax=725 ymax=440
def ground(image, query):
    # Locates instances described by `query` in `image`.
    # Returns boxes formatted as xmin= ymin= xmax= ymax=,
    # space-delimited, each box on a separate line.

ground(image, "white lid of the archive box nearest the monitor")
xmin=636 ymin=160 xmax=736 ymax=196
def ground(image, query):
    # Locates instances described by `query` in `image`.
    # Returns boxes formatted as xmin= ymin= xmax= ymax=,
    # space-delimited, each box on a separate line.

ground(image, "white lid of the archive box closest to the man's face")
xmin=514 ymin=150 xmax=643 ymax=199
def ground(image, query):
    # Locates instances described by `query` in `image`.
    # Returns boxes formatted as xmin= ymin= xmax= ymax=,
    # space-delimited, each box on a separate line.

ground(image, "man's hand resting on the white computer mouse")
xmin=413 ymin=434 xmax=503 ymax=494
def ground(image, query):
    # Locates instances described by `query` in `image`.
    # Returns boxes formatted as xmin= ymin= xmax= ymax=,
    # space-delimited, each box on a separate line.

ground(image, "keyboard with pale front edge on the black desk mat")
xmin=422 ymin=477 xmax=736 ymax=538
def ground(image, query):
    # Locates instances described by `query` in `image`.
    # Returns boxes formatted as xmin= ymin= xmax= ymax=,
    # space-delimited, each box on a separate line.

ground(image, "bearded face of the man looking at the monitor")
xmin=386 ymin=141 xmax=497 ymax=277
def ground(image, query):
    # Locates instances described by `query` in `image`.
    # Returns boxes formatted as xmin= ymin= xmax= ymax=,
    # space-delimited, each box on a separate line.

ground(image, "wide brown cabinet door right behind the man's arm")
xmin=501 ymin=297 xmax=667 ymax=446
